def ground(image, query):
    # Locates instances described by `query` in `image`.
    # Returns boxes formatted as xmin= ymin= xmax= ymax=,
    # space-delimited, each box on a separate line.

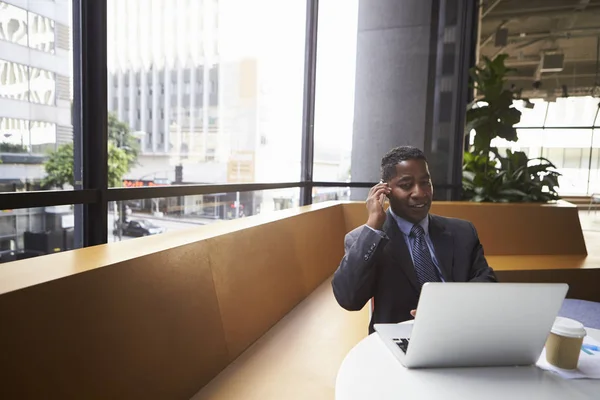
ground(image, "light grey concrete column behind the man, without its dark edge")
xmin=351 ymin=0 xmax=433 ymax=200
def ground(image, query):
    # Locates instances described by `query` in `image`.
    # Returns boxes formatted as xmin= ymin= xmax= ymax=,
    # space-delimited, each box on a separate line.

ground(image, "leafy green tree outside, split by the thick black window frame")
xmin=42 ymin=143 xmax=130 ymax=188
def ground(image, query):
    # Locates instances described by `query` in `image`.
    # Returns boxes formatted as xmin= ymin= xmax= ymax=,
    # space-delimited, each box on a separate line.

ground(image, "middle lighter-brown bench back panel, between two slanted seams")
xmin=208 ymin=222 xmax=307 ymax=360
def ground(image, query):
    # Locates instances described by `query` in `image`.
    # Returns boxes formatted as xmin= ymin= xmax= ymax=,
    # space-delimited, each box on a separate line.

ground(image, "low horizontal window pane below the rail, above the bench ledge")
xmin=108 ymin=188 xmax=300 ymax=243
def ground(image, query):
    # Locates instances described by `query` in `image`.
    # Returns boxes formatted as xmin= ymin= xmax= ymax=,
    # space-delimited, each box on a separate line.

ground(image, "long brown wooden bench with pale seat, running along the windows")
xmin=0 ymin=202 xmax=600 ymax=399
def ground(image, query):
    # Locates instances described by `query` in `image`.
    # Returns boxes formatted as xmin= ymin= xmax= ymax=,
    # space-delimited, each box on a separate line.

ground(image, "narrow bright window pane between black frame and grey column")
xmin=313 ymin=0 xmax=358 ymax=182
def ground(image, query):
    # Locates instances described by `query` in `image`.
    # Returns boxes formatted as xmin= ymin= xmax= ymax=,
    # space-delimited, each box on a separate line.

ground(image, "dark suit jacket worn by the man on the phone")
xmin=332 ymin=211 xmax=496 ymax=333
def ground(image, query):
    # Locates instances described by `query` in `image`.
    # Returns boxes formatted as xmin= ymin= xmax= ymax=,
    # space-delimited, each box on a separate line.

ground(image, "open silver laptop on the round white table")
xmin=374 ymin=282 xmax=569 ymax=368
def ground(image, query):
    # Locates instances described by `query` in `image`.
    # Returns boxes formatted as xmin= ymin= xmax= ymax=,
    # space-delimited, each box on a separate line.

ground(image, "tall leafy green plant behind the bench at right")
xmin=463 ymin=54 xmax=560 ymax=203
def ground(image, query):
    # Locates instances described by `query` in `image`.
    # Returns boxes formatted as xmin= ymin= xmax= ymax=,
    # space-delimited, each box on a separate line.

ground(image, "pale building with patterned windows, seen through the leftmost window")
xmin=0 ymin=0 xmax=73 ymax=259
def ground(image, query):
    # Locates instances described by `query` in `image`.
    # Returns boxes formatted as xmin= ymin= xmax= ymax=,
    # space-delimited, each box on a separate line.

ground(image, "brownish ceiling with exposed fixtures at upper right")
xmin=478 ymin=0 xmax=600 ymax=101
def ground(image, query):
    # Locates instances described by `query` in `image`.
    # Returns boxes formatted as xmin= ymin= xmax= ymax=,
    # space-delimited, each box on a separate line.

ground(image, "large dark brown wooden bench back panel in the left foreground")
xmin=0 ymin=241 xmax=229 ymax=399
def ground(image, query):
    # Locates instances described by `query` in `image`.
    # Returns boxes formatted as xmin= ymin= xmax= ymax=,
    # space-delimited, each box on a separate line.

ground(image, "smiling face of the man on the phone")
xmin=387 ymin=160 xmax=433 ymax=224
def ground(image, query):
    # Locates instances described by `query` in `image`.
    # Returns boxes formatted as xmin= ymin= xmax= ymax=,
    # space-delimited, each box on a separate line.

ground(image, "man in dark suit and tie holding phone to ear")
xmin=332 ymin=146 xmax=496 ymax=333
